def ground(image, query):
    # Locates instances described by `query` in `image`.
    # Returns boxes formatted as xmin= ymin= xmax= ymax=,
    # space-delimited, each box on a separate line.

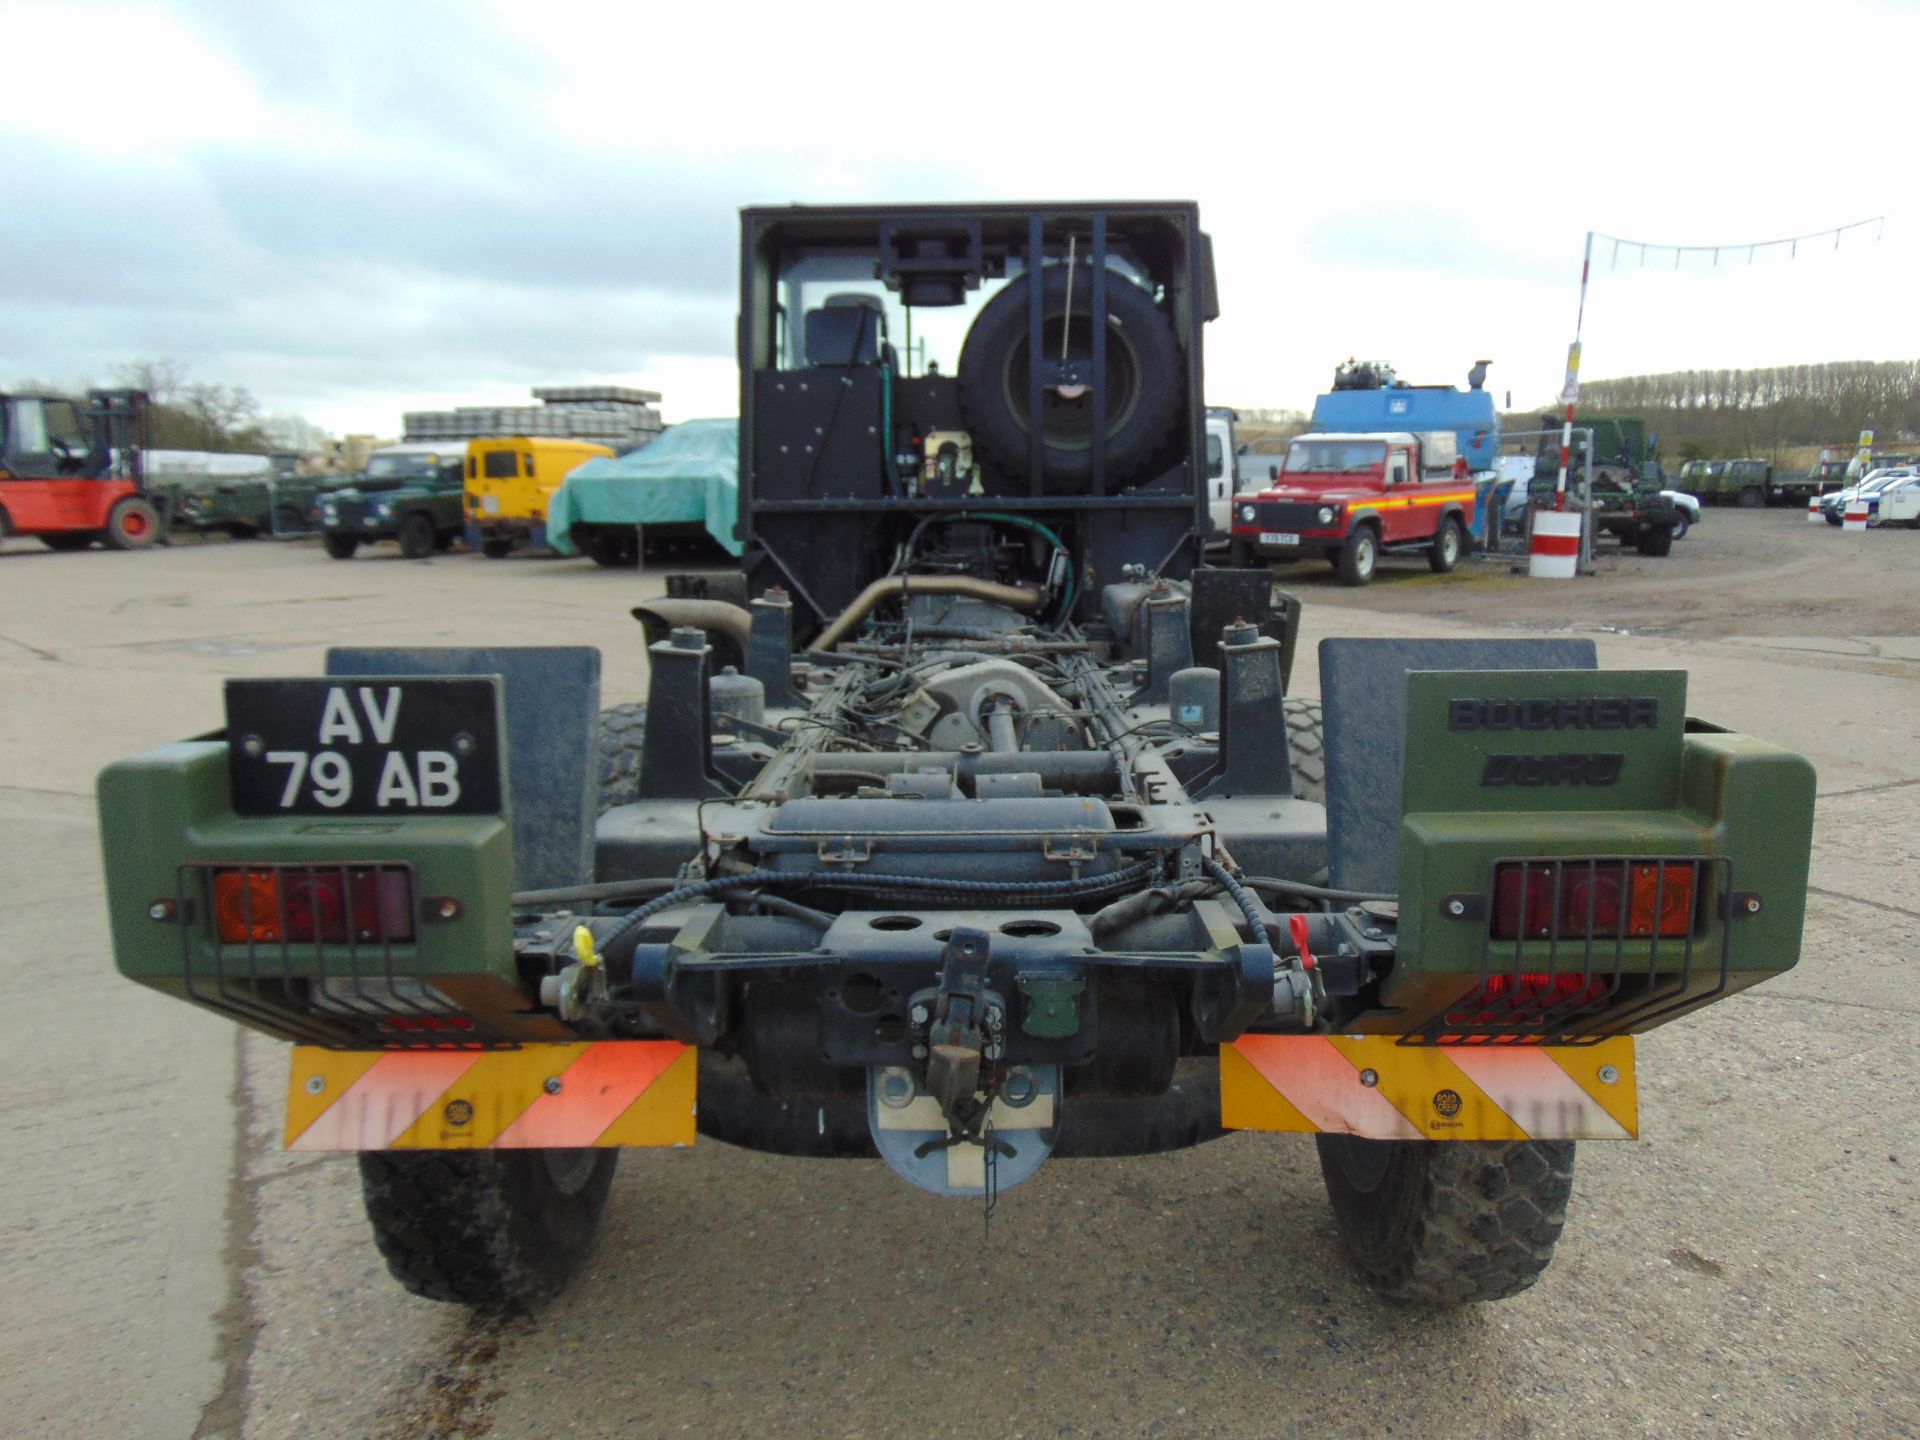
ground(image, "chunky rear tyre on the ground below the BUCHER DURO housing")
xmin=1315 ymin=1135 xmax=1572 ymax=1306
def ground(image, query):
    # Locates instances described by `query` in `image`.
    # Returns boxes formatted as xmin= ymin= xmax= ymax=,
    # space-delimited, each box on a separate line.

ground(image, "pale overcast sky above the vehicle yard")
xmin=0 ymin=0 xmax=1920 ymax=434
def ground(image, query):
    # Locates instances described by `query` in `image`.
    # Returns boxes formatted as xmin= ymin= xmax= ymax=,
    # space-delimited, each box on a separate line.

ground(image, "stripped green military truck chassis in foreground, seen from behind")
xmin=100 ymin=202 xmax=1814 ymax=1306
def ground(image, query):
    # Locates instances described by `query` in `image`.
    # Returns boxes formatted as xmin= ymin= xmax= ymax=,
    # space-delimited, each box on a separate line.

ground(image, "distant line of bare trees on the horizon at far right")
xmin=1559 ymin=361 xmax=1920 ymax=459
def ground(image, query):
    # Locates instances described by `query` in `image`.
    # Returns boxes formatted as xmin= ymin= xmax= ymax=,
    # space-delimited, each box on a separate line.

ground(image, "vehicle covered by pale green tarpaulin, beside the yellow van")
xmin=547 ymin=420 xmax=741 ymax=555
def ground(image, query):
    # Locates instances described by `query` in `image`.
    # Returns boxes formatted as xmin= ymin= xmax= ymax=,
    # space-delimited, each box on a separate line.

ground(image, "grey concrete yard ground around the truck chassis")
xmin=0 ymin=511 xmax=1920 ymax=1440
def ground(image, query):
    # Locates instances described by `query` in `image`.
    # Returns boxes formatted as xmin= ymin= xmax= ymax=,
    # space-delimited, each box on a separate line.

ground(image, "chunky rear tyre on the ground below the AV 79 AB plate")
xmin=359 ymin=1150 xmax=620 ymax=1306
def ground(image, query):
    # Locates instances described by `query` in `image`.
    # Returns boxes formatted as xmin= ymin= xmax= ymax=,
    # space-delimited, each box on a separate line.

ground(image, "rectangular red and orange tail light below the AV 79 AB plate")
xmin=213 ymin=866 xmax=413 ymax=945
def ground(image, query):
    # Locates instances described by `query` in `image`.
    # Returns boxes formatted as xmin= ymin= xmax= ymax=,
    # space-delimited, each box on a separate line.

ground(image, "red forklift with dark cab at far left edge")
xmin=0 ymin=390 xmax=167 ymax=551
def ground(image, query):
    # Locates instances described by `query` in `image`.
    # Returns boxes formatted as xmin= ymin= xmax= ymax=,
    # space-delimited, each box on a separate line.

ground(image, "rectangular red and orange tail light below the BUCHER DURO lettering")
xmin=1490 ymin=860 xmax=1699 ymax=940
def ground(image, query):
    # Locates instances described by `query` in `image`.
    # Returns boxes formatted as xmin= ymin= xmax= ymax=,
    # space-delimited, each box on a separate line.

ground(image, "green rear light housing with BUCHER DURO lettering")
xmin=1382 ymin=670 xmax=1814 ymax=1041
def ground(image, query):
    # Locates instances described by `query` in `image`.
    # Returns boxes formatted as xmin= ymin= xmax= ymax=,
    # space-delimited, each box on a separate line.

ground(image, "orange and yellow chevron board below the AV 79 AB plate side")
xmin=286 ymin=1041 xmax=699 ymax=1150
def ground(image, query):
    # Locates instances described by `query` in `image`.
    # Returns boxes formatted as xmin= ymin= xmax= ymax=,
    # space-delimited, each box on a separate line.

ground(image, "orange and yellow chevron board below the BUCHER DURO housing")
xmin=1219 ymin=1035 xmax=1640 ymax=1140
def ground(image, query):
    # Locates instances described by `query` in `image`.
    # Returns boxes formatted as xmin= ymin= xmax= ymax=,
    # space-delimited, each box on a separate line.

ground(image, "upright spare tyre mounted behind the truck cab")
xmin=958 ymin=265 xmax=1185 ymax=488
